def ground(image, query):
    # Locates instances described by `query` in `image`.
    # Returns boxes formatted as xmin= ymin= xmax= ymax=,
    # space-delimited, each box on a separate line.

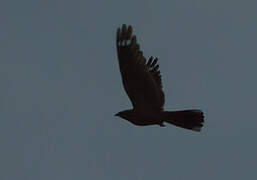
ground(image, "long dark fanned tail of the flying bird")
xmin=163 ymin=109 xmax=204 ymax=132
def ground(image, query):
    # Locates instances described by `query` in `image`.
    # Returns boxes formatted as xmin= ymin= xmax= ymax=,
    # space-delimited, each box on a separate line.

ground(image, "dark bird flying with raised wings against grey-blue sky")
xmin=115 ymin=24 xmax=204 ymax=132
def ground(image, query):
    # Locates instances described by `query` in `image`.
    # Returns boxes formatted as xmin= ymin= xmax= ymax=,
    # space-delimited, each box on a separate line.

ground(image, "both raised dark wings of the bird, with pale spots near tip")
xmin=116 ymin=25 xmax=164 ymax=110
